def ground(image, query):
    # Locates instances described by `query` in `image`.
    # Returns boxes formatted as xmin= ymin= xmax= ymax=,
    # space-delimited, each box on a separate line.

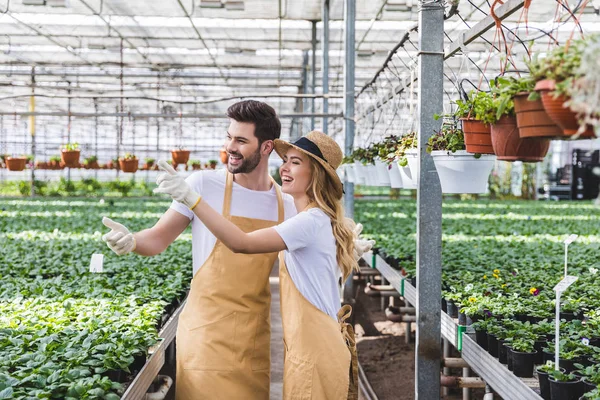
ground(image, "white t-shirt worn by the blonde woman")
xmin=275 ymin=208 xmax=342 ymax=321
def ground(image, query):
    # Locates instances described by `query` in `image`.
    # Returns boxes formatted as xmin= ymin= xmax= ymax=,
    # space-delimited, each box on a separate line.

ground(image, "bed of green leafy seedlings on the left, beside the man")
xmin=0 ymin=199 xmax=191 ymax=399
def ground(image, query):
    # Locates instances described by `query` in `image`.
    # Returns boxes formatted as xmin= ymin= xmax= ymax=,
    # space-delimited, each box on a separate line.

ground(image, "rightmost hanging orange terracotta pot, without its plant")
xmin=535 ymin=80 xmax=595 ymax=139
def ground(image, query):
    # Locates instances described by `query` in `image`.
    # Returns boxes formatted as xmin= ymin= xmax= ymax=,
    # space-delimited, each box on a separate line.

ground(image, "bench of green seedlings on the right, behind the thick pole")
xmin=355 ymin=200 xmax=600 ymax=399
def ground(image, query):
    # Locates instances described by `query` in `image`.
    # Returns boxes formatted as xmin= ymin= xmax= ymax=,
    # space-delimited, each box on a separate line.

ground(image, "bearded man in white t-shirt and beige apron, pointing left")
xmin=103 ymin=100 xmax=296 ymax=400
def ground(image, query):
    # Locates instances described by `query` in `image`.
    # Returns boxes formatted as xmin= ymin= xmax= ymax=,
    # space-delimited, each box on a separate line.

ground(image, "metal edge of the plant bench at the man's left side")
xmin=121 ymin=301 xmax=186 ymax=400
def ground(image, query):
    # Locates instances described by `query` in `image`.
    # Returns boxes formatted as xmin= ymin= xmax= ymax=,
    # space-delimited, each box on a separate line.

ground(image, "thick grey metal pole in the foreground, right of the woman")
xmin=415 ymin=0 xmax=444 ymax=400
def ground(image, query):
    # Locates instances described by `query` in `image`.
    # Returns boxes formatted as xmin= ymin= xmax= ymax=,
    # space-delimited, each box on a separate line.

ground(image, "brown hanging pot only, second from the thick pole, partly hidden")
xmin=492 ymin=115 xmax=550 ymax=162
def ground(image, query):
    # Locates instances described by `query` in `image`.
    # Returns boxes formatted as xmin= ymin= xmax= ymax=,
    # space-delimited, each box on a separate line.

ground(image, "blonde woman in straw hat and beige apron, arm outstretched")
xmin=155 ymin=131 xmax=373 ymax=400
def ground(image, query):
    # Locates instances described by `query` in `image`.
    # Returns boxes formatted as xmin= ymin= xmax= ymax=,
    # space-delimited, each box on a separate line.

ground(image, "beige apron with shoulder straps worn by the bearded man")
xmin=176 ymin=173 xmax=284 ymax=400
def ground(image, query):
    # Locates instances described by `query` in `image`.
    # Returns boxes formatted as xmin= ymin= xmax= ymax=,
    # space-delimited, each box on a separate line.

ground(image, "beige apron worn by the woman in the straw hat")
xmin=279 ymin=251 xmax=358 ymax=400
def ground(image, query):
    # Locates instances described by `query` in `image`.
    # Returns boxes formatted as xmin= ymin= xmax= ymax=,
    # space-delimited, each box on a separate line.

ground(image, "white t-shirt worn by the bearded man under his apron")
xmin=171 ymin=169 xmax=297 ymax=276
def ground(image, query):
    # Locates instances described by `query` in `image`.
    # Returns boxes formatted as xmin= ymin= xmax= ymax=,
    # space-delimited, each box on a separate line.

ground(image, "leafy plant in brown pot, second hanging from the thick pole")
xmin=484 ymin=77 xmax=550 ymax=162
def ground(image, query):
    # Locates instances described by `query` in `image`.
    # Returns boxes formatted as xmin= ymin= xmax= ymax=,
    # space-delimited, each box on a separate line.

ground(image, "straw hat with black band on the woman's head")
xmin=275 ymin=131 xmax=344 ymax=198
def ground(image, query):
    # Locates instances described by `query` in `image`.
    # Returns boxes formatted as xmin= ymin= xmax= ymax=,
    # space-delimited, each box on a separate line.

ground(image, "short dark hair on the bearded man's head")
xmin=227 ymin=100 xmax=281 ymax=144
